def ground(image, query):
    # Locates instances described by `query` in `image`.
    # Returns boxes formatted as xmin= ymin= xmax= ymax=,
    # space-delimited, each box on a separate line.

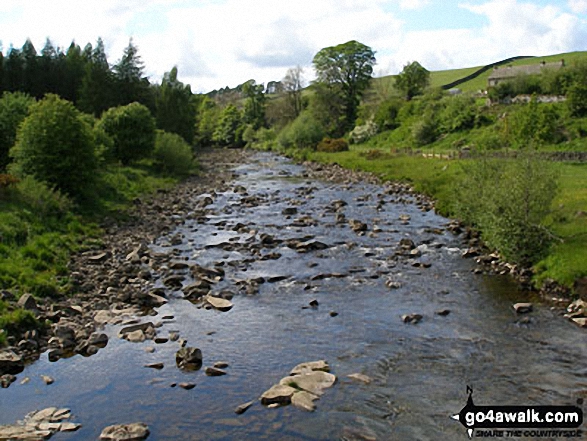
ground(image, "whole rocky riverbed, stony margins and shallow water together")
xmin=0 ymin=150 xmax=587 ymax=440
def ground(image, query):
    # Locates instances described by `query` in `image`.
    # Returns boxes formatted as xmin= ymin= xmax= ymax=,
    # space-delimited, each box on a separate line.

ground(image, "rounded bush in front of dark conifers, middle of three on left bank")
xmin=97 ymin=103 xmax=156 ymax=165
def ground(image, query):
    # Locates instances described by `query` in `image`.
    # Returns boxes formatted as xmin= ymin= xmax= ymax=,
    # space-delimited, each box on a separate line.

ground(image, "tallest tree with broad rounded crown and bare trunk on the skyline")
xmin=313 ymin=40 xmax=376 ymax=131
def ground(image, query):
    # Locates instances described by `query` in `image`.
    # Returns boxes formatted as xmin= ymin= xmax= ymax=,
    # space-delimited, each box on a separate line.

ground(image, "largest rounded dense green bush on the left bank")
xmin=11 ymin=95 xmax=97 ymax=199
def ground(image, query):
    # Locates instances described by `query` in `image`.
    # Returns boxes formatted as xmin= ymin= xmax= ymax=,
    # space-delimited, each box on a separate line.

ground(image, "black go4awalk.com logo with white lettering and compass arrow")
xmin=451 ymin=386 xmax=583 ymax=439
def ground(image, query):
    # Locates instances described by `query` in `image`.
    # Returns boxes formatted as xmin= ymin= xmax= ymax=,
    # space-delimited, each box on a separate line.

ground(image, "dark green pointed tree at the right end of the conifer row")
xmin=155 ymin=66 xmax=197 ymax=143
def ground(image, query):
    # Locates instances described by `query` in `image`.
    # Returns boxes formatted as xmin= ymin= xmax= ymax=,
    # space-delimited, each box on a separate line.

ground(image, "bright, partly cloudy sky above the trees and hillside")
xmin=0 ymin=0 xmax=587 ymax=92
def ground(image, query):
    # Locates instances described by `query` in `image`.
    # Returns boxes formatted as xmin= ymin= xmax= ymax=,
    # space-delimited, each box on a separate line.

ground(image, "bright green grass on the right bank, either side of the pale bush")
xmin=307 ymin=146 xmax=587 ymax=287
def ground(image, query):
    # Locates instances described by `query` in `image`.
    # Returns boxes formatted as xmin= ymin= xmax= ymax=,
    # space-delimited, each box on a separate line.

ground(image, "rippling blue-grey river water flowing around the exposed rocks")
xmin=0 ymin=154 xmax=587 ymax=440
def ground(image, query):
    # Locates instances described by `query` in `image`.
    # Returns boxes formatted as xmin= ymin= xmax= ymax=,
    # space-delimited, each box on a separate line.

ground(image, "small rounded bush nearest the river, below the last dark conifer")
xmin=154 ymin=130 xmax=195 ymax=176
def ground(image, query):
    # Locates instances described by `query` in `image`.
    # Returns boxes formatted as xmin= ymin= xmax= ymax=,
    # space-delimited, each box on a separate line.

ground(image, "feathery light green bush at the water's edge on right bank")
xmin=455 ymin=151 xmax=557 ymax=266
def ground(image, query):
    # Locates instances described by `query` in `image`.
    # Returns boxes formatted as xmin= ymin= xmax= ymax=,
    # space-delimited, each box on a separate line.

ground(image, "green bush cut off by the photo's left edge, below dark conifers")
xmin=0 ymin=92 xmax=35 ymax=172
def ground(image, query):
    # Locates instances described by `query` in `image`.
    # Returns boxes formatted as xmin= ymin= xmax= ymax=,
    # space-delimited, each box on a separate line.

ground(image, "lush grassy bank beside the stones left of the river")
xmin=0 ymin=161 xmax=186 ymax=346
